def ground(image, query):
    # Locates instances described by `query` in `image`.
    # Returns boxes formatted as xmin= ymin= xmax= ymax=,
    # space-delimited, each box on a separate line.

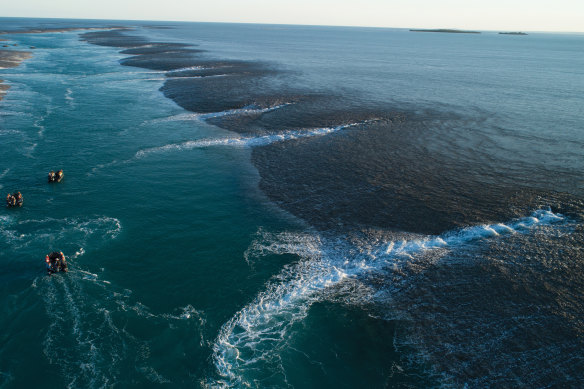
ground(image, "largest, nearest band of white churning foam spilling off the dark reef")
xmin=210 ymin=209 xmax=566 ymax=387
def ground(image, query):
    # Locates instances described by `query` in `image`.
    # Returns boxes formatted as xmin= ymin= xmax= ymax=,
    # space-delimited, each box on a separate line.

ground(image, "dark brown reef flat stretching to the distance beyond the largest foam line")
xmin=83 ymin=30 xmax=576 ymax=234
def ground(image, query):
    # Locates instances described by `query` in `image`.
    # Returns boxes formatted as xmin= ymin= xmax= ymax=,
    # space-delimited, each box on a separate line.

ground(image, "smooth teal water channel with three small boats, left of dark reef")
xmin=2 ymin=28 xmax=290 ymax=387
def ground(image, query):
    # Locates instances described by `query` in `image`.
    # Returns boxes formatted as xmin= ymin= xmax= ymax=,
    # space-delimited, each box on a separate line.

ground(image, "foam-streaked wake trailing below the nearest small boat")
xmin=33 ymin=266 xmax=205 ymax=388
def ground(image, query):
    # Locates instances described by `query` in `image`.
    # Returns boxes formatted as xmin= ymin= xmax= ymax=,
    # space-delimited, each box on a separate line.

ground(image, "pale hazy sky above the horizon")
xmin=0 ymin=0 xmax=584 ymax=32
